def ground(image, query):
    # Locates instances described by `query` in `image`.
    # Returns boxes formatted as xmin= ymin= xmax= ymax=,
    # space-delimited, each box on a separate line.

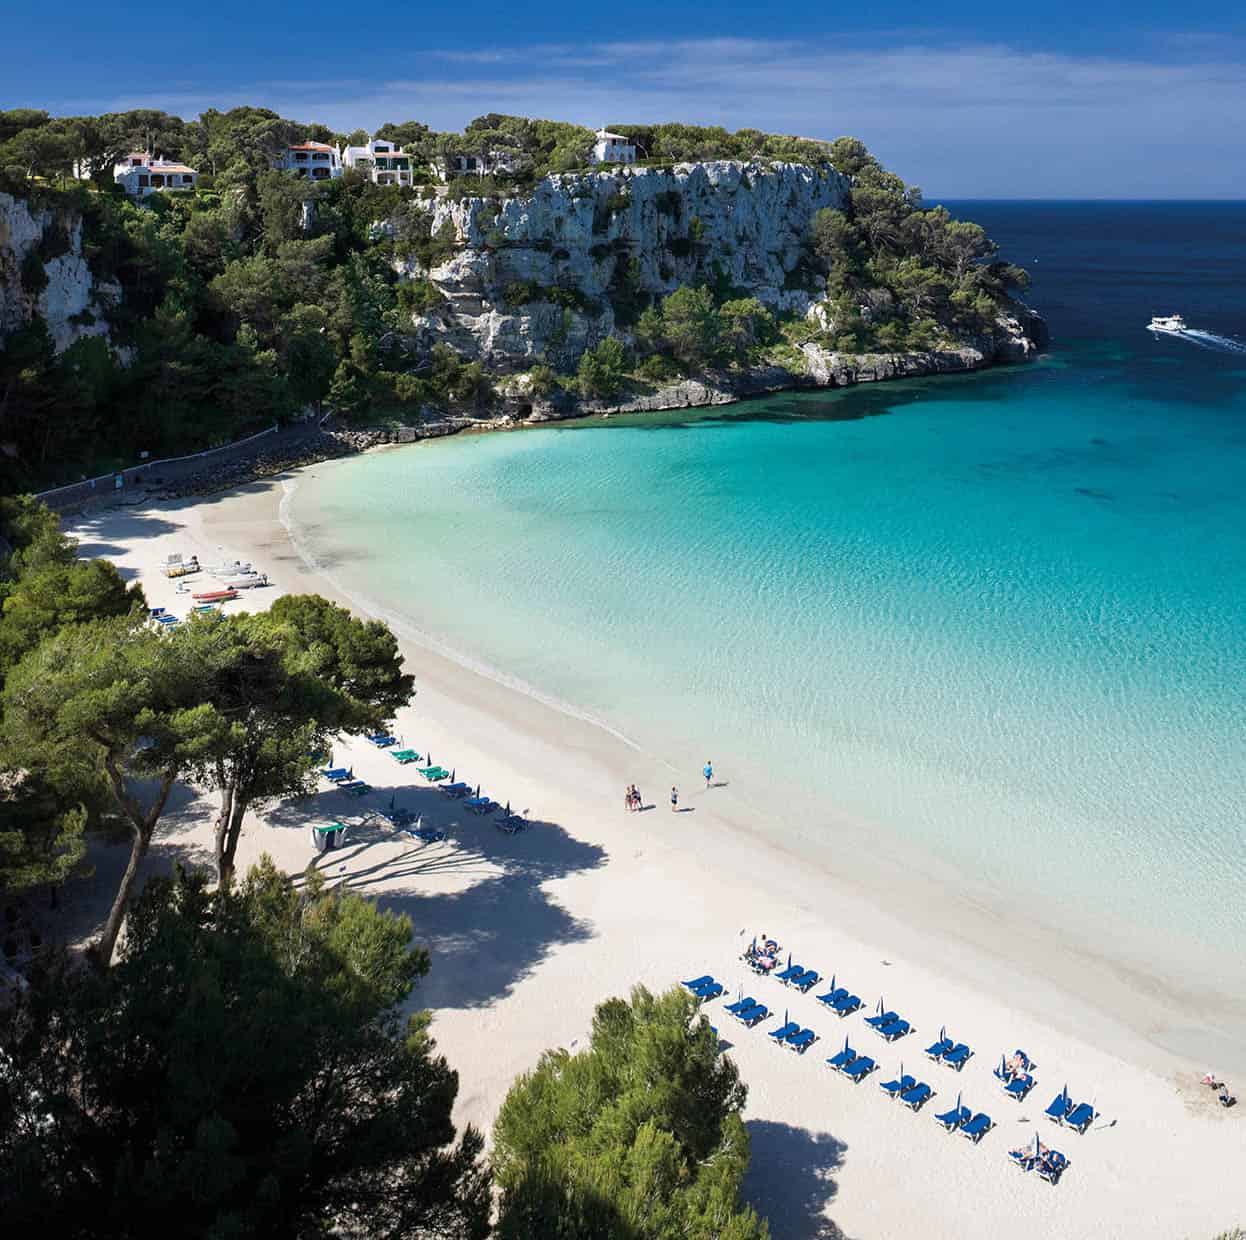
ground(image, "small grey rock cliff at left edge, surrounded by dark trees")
xmin=0 ymin=193 xmax=121 ymax=353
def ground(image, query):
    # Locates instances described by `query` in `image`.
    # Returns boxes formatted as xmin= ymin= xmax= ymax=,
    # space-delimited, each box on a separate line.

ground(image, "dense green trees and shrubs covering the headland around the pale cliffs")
xmin=0 ymin=108 xmax=1024 ymax=490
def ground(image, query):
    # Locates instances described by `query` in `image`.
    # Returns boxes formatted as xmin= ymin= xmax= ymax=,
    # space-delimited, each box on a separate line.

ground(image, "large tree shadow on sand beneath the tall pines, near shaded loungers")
xmin=265 ymin=785 xmax=607 ymax=1008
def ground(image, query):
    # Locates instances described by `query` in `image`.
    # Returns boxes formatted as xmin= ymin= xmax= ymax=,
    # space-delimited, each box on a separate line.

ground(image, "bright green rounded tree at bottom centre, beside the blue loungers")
xmin=493 ymin=987 xmax=769 ymax=1240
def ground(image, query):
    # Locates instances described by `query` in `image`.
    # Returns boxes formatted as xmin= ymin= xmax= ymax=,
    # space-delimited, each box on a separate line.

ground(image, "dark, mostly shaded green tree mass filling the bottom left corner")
xmin=0 ymin=859 xmax=490 ymax=1240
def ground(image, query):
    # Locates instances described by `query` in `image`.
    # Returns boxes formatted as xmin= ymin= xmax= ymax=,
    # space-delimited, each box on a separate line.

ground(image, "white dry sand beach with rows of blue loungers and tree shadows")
xmin=71 ymin=482 xmax=1246 ymax=1240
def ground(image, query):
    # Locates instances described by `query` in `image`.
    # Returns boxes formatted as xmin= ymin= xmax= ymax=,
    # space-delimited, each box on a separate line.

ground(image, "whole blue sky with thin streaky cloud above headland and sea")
xmin=0 ymin=0 xmax=1246 ymax=198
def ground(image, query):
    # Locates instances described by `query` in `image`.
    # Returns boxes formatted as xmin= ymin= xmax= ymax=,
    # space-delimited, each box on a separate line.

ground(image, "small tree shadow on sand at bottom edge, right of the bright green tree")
xmin=744 ymin=1119 xmax=847 ymax=1240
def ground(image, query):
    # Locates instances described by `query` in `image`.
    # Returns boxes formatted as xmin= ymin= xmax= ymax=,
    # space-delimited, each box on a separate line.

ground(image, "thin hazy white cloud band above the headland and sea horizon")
xmin=57 ymin=32 xmax=1246 ymax=197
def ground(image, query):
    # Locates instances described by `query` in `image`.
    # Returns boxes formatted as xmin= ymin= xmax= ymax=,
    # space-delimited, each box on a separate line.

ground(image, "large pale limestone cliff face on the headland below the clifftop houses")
xmin=401 ymin=161 xmax=849 ymax=371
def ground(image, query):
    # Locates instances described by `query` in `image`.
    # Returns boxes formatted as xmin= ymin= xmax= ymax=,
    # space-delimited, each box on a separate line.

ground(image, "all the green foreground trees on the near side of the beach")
xmin=0 ymin=498 xmax=782 ymax=1240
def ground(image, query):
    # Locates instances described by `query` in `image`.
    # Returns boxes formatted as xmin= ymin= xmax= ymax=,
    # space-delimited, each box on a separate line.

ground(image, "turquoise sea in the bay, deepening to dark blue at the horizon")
xmin=284 ymin=202 xmax=1246 ymax=1051
